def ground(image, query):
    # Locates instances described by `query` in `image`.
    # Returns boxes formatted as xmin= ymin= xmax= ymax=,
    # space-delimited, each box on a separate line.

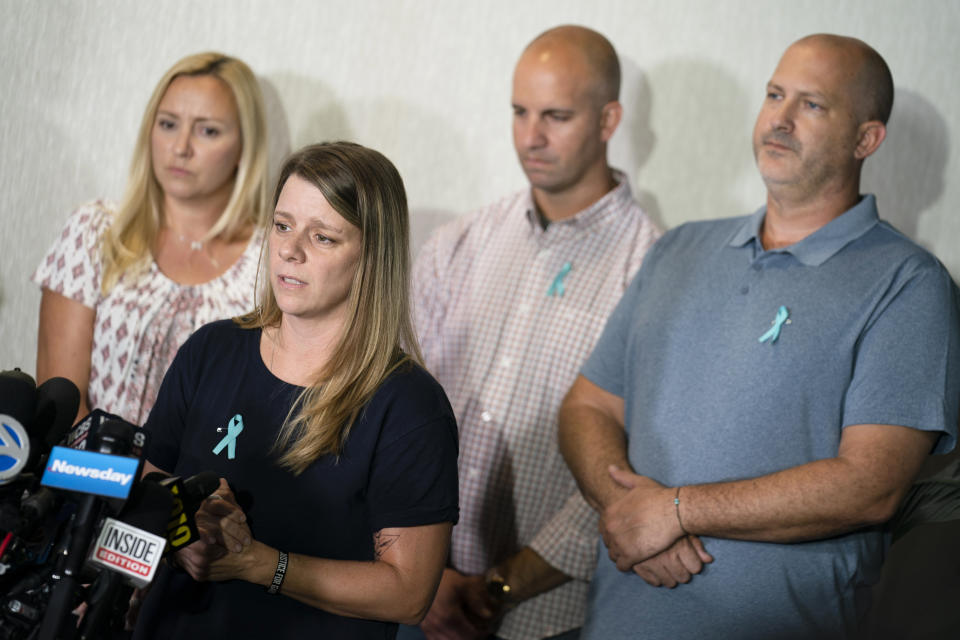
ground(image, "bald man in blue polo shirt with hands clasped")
xmin=560 ymin=34 xmax=960 ymax=640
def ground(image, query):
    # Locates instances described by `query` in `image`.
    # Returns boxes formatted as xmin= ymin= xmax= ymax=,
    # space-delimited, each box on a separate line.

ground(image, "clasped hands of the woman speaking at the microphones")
xmin=176 ymin=478 xmax=253 ymax=581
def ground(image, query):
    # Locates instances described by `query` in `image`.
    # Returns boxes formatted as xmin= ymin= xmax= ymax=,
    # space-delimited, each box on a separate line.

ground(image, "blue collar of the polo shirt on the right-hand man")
xmin=730 ymin=193 xmax=879 ymax=267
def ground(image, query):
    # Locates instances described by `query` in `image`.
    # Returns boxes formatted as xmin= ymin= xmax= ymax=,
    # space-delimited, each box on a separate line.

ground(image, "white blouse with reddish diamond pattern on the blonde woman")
xmin=31 ymin=200 xmax=263 ymax=425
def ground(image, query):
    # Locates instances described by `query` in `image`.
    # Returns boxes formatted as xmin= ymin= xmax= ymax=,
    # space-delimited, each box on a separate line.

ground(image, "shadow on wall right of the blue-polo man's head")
xmin=861 ymin=89 xmax=950 ymax=241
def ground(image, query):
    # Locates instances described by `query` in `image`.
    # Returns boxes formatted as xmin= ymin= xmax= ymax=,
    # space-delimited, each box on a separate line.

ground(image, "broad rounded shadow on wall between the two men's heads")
xmin=638 ymin=58 xmax=760 ymax=229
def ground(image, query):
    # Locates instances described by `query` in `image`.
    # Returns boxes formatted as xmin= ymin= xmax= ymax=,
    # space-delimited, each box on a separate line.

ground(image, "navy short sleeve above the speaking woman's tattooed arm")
xmin=367 ymin=370 xmax=459 ymax=531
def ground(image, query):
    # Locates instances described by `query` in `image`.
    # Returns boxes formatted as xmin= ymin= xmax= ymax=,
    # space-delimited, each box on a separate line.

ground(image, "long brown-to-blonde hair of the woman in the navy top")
xmin=236 ymin=142 xmax=422 ymax=474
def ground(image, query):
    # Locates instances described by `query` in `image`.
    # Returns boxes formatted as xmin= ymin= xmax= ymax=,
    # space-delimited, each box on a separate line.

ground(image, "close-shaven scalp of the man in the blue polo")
xmin=790 ymin=33 xmax=893 ymax=124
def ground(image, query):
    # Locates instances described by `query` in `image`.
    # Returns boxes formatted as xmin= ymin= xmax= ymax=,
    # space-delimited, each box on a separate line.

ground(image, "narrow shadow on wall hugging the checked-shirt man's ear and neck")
xmin=609 ymin=56 xmax=664 ymax=228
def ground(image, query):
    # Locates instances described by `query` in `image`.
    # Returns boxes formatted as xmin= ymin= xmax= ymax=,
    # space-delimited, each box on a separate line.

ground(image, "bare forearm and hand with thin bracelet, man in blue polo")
xmin=601 ymin=424 xmax=937 ymax=569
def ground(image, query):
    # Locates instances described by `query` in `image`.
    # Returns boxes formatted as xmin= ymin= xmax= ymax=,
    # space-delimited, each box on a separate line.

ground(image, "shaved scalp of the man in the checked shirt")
xmin=518 ymin=25 xmax=620 ymax=105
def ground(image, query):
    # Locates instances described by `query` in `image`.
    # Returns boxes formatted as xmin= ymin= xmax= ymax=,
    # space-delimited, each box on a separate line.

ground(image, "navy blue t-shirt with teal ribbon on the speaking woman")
xmin=135 ymin=320 xmax=458 ymax=640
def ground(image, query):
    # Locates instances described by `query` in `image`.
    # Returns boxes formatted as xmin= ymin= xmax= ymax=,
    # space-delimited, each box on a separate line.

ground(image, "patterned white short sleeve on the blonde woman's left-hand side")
xmin=31 ymin=200 xmax=113 ymax=308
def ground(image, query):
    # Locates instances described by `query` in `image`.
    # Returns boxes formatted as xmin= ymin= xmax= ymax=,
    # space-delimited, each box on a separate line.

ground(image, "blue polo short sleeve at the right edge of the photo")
xmin=843 ymin=256 xmax=960 ymax=453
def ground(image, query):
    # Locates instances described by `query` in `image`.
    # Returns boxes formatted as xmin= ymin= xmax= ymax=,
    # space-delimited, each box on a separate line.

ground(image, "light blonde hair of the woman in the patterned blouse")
xmin=101 ymin=52 xmax=269 ymax=294
